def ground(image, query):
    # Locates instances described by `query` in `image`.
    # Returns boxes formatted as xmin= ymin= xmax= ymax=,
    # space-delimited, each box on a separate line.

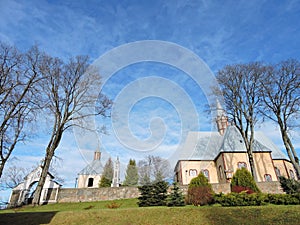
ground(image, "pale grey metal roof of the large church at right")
xmin=179 ymin=126 xmax=287 ymax=160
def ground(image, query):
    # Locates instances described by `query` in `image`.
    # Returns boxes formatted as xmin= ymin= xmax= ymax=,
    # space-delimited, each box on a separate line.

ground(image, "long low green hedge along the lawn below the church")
xmin=214 ymin=192 xmax=300 ymax=206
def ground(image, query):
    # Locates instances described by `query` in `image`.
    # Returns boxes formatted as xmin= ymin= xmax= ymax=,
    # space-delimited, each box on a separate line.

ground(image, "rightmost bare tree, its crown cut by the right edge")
xmin=261 ymin=60 xmax=300 ymax=177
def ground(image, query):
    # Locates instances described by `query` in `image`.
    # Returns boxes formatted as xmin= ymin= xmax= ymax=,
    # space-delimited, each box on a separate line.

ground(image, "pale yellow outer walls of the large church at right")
xmin=175 ymin=152 xmax=296 ymax=185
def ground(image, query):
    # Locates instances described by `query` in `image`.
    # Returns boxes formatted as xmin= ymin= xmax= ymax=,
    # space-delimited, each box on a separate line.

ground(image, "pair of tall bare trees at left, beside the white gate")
xmin=0 ymin=43 xmax=112 ymax=204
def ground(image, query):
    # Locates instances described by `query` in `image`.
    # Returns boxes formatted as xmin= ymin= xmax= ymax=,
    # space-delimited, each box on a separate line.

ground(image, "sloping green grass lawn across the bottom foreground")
xmin=0 ymin=199 xmax=300 ymax=225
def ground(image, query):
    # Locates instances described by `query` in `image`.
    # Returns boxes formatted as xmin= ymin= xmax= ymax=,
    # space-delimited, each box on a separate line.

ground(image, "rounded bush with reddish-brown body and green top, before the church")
xmin=186 ymin=173 xmax=214 ymax=206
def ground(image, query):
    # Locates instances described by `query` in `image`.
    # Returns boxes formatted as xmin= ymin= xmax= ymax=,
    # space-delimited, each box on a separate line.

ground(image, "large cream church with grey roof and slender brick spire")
xmin=174 ymin=103 xmax=296 ymax=185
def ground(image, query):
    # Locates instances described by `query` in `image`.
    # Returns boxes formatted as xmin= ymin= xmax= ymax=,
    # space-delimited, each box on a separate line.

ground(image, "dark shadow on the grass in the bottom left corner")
xmin=0 ymin=212 xmax=57 ymax=225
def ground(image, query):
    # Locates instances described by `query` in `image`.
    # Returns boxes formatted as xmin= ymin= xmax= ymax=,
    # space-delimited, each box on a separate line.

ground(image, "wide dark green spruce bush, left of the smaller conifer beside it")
xmin=138 ymin=181 xmax=168 ymax=207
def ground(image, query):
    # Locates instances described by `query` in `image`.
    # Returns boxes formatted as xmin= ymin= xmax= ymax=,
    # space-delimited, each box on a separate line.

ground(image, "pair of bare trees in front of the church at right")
xmin=212 ymin=59 xmax=300 ymax=180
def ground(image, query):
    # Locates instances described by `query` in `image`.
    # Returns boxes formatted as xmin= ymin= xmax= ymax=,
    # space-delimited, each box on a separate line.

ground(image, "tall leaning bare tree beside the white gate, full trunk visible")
xmin=33 ymin=56 xmax=111 ymax=204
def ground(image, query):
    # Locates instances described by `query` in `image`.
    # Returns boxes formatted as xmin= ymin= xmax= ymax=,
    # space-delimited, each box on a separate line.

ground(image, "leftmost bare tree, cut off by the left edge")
xmin=0 ymin=43 xmax=42 ymax=177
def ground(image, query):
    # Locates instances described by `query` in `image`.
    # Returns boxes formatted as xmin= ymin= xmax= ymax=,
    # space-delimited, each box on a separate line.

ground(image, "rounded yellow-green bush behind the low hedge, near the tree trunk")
xmin=231 ymin=168 xmax=260 ymax=193
